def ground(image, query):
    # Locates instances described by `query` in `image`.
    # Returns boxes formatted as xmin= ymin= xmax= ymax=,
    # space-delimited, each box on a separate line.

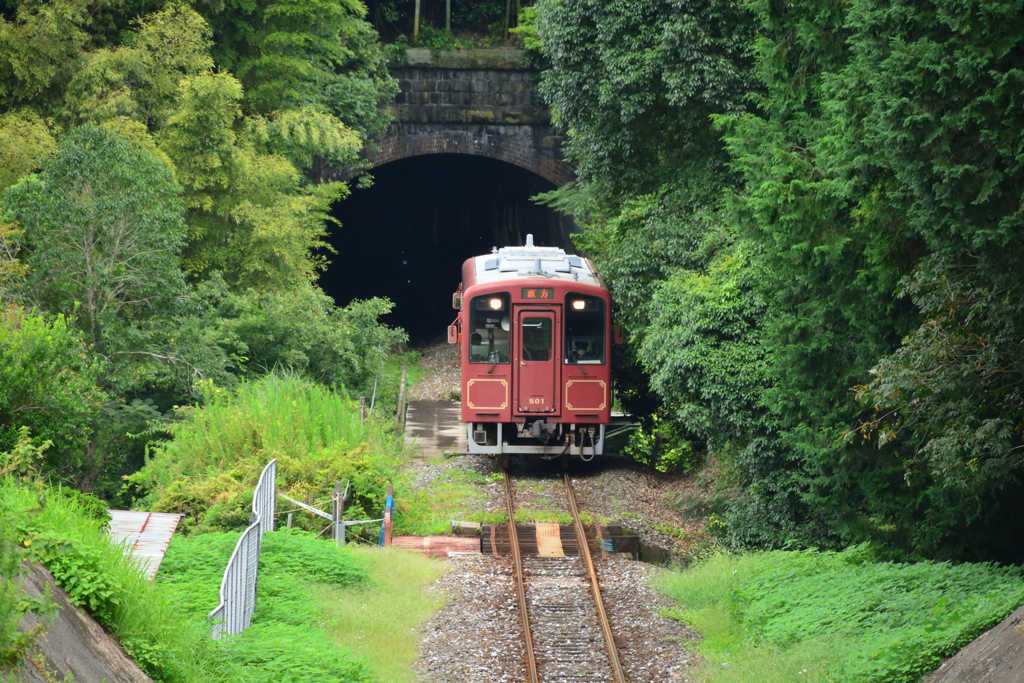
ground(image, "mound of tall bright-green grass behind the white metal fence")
xmin=130 ymin=372 xmax=402 ymax=531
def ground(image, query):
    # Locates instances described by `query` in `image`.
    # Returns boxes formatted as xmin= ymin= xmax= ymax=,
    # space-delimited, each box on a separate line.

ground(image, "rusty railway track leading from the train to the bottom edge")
xmin=505 ymin=470 xmax=627 ymax=683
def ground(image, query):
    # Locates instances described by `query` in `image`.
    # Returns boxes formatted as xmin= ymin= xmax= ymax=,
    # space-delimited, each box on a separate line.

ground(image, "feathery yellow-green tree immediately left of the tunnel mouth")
xmin=161 ymin=73 xmax=347 ymax=288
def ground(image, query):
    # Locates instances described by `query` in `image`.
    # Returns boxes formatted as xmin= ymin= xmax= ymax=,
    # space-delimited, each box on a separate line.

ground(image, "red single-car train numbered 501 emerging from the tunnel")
xmin=449 ymin=234 xmax=617 ymax=460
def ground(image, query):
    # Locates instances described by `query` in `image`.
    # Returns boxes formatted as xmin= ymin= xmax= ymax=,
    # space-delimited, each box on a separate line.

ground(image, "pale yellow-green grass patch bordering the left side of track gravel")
xmin=315 ymin=546 xmax=444 ymax=683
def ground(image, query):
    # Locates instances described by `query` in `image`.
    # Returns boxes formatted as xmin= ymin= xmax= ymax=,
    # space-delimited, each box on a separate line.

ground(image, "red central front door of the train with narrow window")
xmin=515 ymin=307 xmax=559 ymax=415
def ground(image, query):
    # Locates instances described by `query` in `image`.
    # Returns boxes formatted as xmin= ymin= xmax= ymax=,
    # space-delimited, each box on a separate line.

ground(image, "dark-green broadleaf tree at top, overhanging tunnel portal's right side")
xmin=537 ymin=0 xmax=756 ymax=198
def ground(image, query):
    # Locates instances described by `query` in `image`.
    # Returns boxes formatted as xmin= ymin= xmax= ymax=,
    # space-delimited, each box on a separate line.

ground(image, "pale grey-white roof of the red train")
xmin=471 ymin=234 xmax=604 ymax=288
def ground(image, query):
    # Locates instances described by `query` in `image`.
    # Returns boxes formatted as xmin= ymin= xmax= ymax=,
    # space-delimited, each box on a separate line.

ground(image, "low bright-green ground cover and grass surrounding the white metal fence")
xmin=0 ymin=438 xmax=441 ymax=683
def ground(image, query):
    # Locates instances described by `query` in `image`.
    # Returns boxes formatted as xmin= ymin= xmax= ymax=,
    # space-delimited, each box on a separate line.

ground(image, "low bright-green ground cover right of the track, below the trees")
xmin=655 ymin=546 xmax=1024 ymax=683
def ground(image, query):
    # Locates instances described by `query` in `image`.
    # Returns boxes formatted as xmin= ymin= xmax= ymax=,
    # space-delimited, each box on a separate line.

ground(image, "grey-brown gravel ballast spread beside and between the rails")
xmin=410 ymin=344 xmax=703 ymax=683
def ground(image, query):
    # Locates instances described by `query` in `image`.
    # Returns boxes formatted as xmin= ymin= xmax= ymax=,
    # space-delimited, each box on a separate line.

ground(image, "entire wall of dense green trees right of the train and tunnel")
xmin=532 ymin=0 xmax=1024 ymax=561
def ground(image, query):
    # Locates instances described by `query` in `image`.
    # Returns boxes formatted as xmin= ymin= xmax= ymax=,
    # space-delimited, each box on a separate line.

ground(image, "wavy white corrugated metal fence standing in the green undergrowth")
xmin=206 ymin=459 xmax=278 ymax=640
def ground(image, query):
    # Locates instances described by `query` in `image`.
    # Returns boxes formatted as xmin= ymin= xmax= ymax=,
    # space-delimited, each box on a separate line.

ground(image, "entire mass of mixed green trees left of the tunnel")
xmin=0 ymin=0 xmax=404 ymax=505
